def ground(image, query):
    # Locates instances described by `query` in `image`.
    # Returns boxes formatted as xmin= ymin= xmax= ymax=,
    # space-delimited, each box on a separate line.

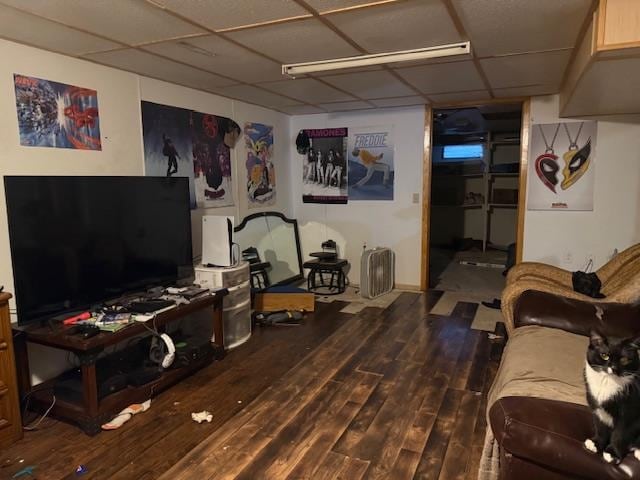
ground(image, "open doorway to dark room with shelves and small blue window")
xmin=423 ymin=102 xmax=528 ymax=301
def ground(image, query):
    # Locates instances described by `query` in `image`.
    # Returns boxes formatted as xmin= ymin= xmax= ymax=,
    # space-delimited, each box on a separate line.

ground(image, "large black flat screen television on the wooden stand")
xmin=4 ymin=176 xmax=193 ymax=324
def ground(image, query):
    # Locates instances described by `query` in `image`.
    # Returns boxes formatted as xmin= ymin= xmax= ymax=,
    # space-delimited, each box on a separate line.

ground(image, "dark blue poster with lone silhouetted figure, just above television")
xmin=141 ymin=102 xmax=196 ymax=208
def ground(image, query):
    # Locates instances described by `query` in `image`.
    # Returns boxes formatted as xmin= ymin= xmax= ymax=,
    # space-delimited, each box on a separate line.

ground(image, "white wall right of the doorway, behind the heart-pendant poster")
xmin=523 ymin=95 xmax=640 ymax=270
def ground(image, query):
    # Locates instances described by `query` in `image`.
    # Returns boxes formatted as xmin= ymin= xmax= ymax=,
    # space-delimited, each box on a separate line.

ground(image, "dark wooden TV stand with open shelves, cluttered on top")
xmin=13 ymin=290 xmax=227 ymax=435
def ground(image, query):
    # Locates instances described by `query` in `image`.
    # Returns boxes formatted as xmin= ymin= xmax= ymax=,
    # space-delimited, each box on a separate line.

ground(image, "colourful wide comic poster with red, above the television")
xmin=13 ymin=74 xmax=102 ymax=150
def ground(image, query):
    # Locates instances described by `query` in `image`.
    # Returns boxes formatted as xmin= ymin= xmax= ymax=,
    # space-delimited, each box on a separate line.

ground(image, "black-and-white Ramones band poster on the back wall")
xmin=302 ymin=128 xmax=349 ymax=203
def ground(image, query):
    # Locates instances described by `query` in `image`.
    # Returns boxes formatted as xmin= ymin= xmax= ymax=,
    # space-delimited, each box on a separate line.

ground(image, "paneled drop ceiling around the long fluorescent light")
xmin=0 ymin=0 xmax=594 ymax=115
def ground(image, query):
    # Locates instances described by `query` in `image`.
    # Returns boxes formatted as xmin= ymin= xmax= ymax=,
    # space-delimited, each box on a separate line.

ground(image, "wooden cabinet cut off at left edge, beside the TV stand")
xmin=0 ymin=293 xmax=22 ymax=448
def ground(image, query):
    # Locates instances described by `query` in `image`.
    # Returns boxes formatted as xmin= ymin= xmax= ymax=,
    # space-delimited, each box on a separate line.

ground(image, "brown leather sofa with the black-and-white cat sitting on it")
xmin=489 ymin=291 xmax=640 ymax=480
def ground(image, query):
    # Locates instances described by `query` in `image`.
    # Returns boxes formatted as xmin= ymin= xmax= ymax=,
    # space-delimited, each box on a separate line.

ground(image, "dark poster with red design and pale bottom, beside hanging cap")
xmin=194 ymin=111 xmax=233 ymax=208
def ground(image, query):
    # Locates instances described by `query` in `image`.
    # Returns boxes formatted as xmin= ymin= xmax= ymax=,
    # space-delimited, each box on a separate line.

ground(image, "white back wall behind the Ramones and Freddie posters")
xmin=289 ymin=106 xmax=424 ymax=286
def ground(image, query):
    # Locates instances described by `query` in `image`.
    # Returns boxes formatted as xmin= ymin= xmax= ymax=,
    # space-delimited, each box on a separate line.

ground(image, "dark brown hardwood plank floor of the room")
xmin=0 ymin=291 xmax=499 ymax=480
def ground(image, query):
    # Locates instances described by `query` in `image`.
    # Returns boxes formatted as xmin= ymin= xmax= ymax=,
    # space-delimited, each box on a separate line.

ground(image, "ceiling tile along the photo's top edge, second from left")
xmin=154 ymin=0 xmax=310 ymax=30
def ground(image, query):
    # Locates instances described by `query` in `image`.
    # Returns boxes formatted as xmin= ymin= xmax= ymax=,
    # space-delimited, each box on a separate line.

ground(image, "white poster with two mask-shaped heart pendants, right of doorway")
xmin=527 ymin=121 xmax=597 ymax=211
